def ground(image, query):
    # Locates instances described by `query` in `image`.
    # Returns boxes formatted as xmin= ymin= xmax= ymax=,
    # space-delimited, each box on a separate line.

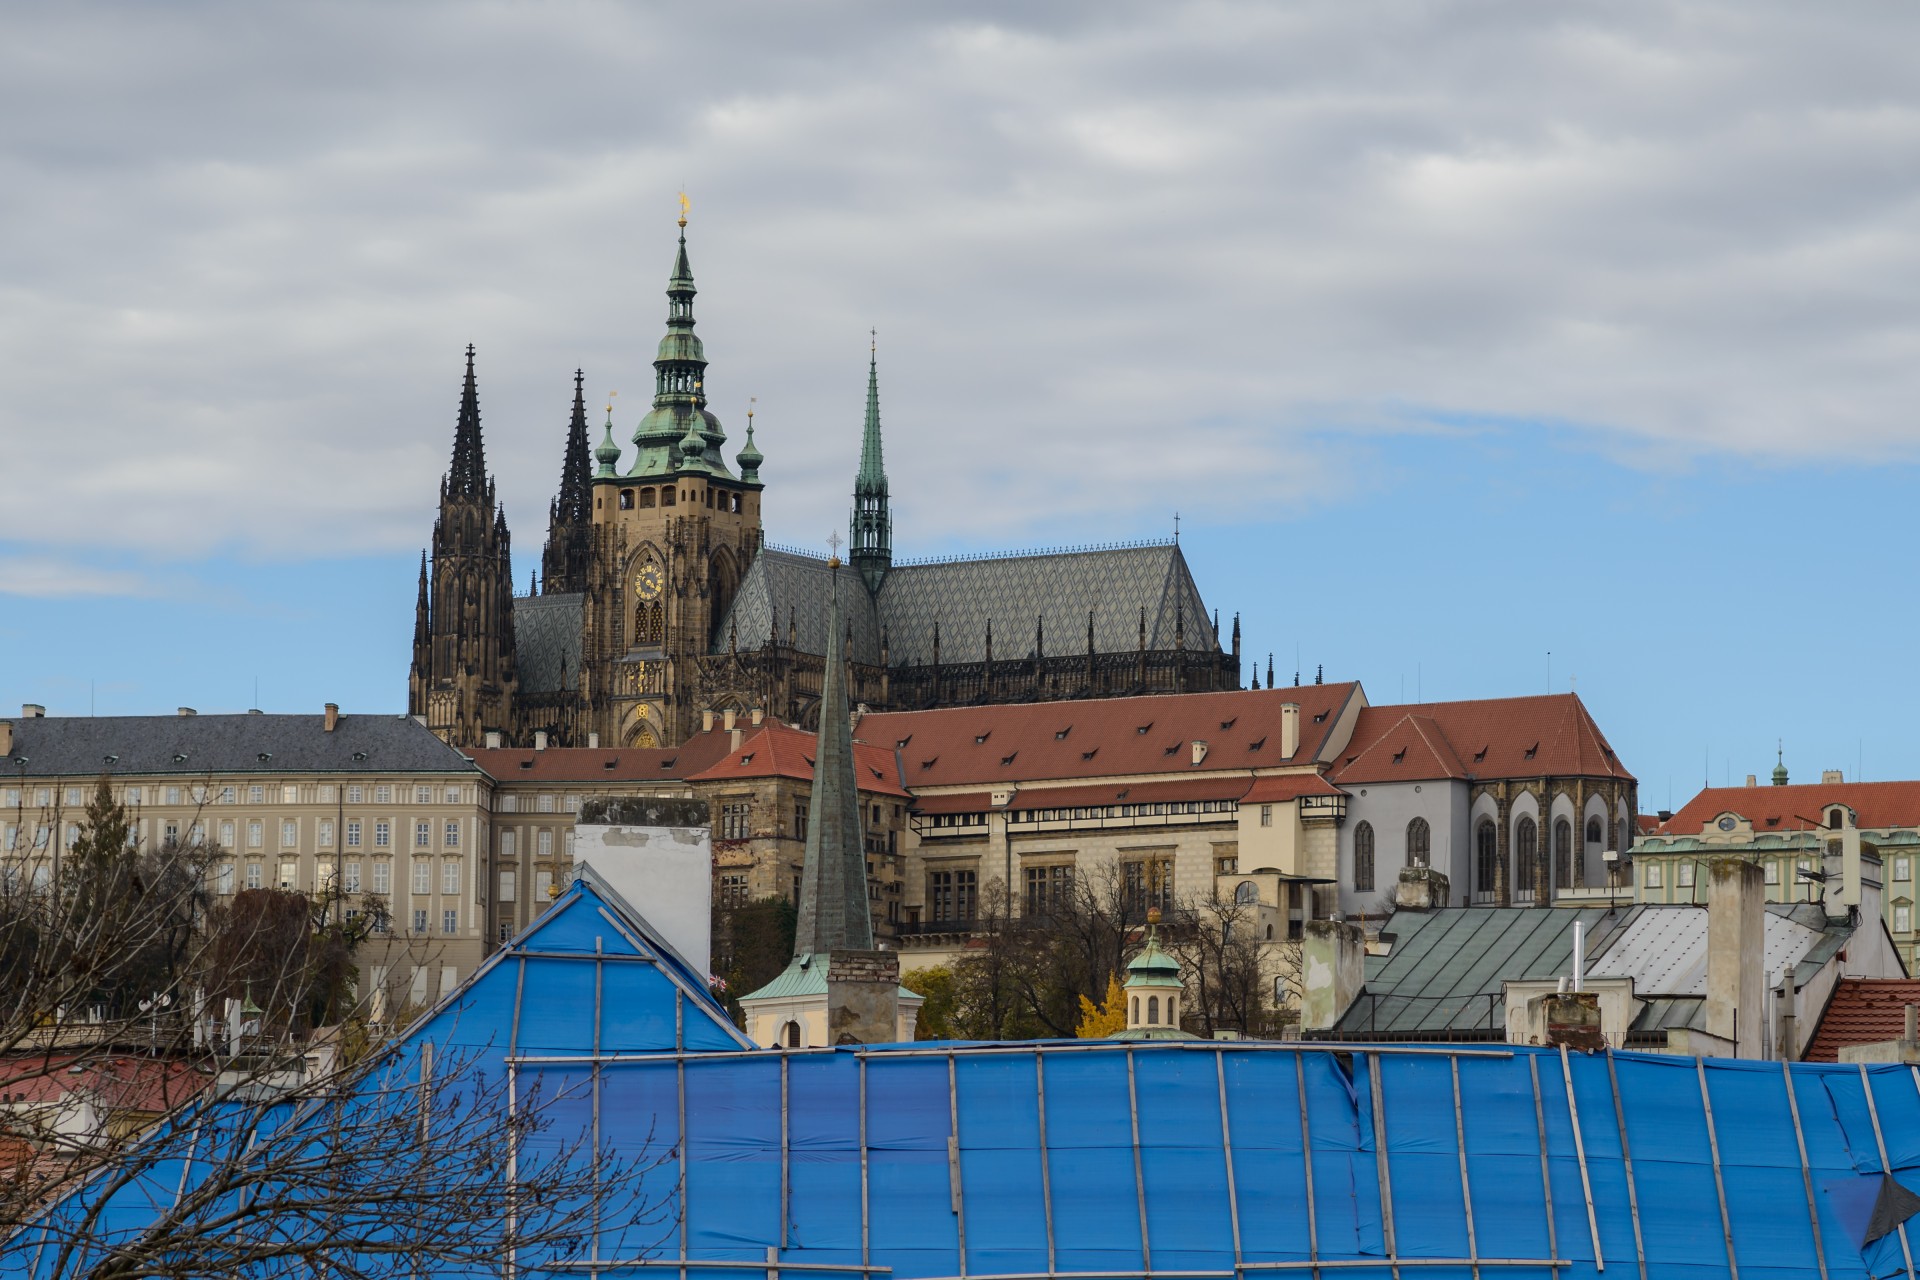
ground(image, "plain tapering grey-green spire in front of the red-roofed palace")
xmin=793 ymin=557 xmax=874 ymax=958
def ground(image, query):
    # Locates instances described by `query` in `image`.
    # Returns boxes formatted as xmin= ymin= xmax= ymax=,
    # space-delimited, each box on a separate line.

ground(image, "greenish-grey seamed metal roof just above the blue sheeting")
xmin=1338 ymin=906 xmax=1640 ymax=1036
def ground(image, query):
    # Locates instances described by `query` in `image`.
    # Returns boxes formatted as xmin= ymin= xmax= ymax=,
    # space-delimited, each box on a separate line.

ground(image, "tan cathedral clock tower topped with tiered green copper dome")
xmin=582 ymin=206 xmax=762 ymax=747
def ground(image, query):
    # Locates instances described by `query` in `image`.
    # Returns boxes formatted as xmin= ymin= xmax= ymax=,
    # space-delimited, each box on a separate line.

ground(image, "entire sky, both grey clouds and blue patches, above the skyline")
xmin=0 ymin=0 xmax=1920 ymax=808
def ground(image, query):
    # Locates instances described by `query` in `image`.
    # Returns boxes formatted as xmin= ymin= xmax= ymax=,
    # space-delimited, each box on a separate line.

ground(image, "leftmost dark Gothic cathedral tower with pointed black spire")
xmin=407 ymin=345 xmax=516 ymax=747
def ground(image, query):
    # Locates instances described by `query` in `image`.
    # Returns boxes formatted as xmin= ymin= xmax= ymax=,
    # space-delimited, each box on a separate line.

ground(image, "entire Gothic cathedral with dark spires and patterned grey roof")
xmin=409 ymin=219 xmax=1240 ymax=748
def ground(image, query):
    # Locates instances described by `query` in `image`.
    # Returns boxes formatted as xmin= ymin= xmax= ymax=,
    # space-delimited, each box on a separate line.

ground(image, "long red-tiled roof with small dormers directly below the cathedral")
xmin=854 ymin=683 xmax=1365 ymax=787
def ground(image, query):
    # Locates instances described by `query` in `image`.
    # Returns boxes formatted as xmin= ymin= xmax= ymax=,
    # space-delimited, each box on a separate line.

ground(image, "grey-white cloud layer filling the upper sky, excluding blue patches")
xmin=0 ymin=0 xmax=1920 ymax=560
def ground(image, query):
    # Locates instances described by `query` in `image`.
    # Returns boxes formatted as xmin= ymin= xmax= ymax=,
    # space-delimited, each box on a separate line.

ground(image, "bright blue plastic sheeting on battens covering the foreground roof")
xmin=11 ymin=871 xmax=1920 ymax=1280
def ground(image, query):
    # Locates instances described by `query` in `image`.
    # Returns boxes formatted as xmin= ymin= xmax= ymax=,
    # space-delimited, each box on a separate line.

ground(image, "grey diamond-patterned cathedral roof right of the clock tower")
xmin=712 ymin=543 xmax=1215 ymax=666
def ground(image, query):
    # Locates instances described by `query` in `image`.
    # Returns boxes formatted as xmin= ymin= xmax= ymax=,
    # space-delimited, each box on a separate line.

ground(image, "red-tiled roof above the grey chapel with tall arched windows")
xmin=1332 ymin=693 xmax=1634 ymax=785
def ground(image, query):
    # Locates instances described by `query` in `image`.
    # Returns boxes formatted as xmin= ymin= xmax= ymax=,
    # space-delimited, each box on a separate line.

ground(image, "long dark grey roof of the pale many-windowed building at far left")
xmin=0 ymin=712 xmax=478 ymax=777
